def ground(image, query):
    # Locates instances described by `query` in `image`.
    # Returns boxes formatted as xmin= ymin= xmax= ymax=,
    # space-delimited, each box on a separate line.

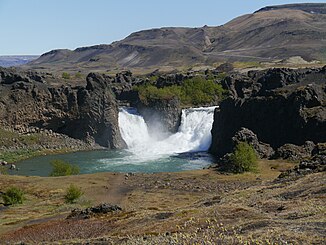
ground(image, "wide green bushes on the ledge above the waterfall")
xmin=134 ymin=76 xmax=225 ymax=105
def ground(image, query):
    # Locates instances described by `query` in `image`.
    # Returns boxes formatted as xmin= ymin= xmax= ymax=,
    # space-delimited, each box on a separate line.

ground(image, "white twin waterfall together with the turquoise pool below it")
xmin=11 ymin=107 xmax=215 ymax=176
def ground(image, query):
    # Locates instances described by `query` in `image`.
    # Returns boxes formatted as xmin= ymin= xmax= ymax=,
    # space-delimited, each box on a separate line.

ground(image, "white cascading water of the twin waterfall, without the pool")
xmin=119 ymin=107 xmax=216 ymax=162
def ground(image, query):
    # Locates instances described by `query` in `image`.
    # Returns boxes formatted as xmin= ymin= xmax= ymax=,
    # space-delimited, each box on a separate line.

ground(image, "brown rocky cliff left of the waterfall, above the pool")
xmin=0 ymin=69 xmax=125 ymax=149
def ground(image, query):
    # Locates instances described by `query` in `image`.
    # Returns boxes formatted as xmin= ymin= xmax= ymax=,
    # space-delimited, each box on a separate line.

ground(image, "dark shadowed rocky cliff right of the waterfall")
xmin=210 ymin=67 xmax=326 ymax=157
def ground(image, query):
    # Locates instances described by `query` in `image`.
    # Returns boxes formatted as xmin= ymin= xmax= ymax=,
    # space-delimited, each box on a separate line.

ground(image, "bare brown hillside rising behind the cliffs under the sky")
xmin=28 ymin=4 xmax=326 ymax=71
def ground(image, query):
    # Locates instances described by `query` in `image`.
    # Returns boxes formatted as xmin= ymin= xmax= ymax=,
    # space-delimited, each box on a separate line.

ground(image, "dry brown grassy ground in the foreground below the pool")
xmin=0 ymin=161 xmax=326 ymax=244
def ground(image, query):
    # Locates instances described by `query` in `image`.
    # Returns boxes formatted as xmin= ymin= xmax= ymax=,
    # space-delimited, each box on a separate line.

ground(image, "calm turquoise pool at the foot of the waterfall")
xmin=10 ymin=150 xmax=213 ymax=176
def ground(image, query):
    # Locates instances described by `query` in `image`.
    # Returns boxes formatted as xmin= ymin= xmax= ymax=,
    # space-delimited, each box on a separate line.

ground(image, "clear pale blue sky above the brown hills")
xmin=0 ymin=0 xmax=325 ymax=55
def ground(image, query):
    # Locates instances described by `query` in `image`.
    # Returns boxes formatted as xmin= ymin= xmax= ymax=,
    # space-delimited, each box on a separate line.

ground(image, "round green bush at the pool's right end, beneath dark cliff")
xmin=230 ymin=142 xmax=258 ymax=173
